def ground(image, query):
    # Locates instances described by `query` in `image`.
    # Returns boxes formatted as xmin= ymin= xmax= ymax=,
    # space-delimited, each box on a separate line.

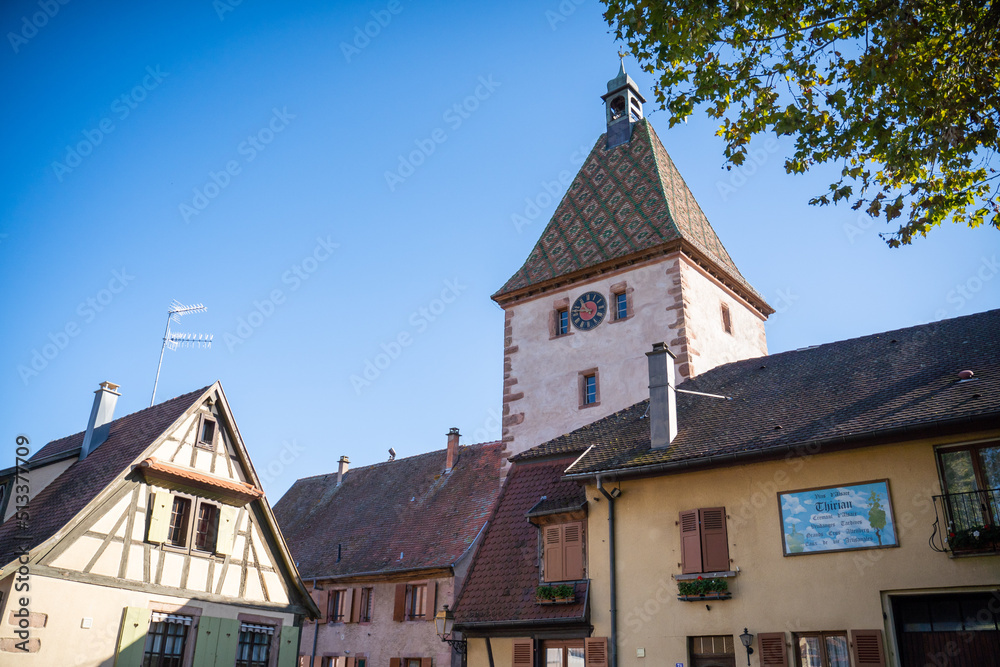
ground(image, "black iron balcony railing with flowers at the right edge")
xmin=930 ymin=489 xmax=1000 ymax=554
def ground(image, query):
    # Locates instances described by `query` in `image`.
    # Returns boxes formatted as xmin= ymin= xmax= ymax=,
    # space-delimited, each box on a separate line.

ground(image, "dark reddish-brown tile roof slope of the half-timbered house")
xmin=0 ymin=385 xmax=211 ymax=566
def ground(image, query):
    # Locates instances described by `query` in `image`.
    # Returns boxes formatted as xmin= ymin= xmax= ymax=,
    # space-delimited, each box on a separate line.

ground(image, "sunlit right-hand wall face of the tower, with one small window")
xmin=680 ymin=259 xmax=767 ymax=377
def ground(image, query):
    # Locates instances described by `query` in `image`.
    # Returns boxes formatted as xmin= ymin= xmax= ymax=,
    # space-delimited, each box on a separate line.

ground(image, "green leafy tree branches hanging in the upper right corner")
xmin=605 ymin=0 xmax=1000 ymax=247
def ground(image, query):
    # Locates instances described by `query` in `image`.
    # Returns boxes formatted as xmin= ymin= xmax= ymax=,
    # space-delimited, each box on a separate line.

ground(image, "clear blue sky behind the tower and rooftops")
xmin=0 ymin=0 xmax=1000 ymax=501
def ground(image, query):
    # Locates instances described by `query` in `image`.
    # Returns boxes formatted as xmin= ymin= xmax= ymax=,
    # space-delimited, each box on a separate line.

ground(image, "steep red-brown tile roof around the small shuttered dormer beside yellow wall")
xmin=455 ymin=458 xmax=587 ymax=625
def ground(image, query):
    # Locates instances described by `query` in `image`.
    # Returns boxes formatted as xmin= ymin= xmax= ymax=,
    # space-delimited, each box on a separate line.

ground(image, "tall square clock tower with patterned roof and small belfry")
xmin=493 ymin=64 xmax=774 ymax=456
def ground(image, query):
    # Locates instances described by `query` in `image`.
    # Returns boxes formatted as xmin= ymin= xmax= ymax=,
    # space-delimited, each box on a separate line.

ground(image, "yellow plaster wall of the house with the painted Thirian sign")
xmin=587 ymin=434 xmax=1000 ymax=667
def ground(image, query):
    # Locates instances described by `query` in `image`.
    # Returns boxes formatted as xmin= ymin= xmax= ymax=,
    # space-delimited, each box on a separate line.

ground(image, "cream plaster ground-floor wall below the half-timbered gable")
xmin=0 ymin=575 xmax=294 ymax=667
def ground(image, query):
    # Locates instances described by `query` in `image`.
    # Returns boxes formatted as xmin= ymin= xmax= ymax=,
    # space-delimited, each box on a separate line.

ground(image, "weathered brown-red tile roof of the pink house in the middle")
xmin=274 ymin=442 xmax=503 ymax=579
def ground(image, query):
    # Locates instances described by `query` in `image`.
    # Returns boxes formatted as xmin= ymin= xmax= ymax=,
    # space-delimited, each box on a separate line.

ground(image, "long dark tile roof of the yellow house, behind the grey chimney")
xmin=514 ymin=310 xmax=1000 ymax=475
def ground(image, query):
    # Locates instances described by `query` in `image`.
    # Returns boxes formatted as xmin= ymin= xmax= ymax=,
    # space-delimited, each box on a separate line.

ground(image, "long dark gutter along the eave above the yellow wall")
xmin=565 ymin=413 xmax=996 ymax=485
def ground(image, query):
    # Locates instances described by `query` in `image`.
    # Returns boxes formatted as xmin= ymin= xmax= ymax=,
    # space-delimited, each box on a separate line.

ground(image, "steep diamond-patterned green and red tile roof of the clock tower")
xmin=493 ymin=119 xmax=760 ymax=299
